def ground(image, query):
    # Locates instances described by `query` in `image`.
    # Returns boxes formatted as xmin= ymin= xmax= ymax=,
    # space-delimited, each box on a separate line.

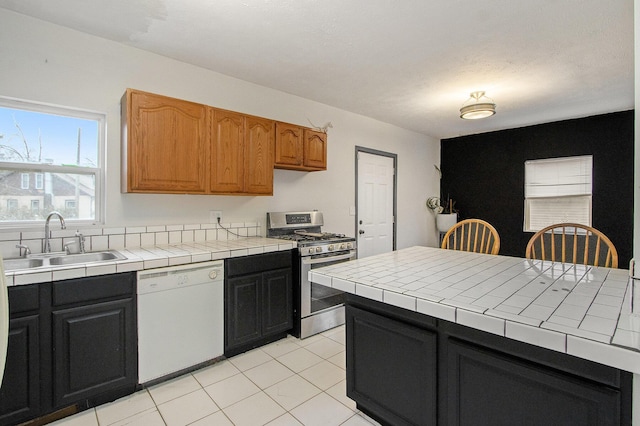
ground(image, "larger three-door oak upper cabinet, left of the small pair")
xmin=121 ymin=89 xmax=275 ymax=195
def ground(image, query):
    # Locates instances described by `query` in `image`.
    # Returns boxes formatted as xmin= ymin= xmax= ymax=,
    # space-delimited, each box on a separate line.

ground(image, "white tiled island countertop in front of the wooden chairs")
xmin=309 ymin=247 xmax=640 ymax=373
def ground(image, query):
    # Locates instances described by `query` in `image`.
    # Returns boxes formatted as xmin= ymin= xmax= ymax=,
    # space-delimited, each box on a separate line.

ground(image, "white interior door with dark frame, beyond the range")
xmin=357 ymin=151 xmax=395 ymax=258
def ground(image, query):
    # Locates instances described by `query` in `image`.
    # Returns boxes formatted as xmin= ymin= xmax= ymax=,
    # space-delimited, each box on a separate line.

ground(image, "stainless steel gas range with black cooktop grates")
xmin=267 ymin=211 xmax=356 ymax=339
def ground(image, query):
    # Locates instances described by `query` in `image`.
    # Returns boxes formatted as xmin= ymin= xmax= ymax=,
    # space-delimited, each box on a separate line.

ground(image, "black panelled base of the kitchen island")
xmin=346 ymin=295 xmax=632 ymax=426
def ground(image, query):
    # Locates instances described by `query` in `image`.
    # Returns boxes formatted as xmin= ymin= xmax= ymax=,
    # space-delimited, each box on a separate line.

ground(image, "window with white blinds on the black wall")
xmin=524 ymin=155 xmax=593 ymax=232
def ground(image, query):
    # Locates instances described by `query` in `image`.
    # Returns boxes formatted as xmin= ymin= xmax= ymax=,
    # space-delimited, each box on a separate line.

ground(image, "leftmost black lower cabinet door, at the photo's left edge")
xmin=0 ymin=315 xmax=41 ymax=425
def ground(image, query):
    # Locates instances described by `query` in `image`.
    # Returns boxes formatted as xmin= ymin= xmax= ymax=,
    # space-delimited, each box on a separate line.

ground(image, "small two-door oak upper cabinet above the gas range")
xmin=275 ymin=122 xmax=327 ymax=171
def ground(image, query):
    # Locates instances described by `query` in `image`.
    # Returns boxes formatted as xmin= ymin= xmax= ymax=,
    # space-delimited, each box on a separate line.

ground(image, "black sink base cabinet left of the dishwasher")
xmin=0 ymin=273 xmax=138 ymax=425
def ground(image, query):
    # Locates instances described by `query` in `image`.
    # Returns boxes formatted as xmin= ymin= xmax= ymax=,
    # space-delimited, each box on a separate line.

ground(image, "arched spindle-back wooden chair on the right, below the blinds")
xmin=525 ymin=223 xmax=618 ymax=268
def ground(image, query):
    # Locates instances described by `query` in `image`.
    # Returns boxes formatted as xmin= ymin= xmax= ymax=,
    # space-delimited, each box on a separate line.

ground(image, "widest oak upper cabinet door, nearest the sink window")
xmin=123 ymin=90 xmax=209 ymax=193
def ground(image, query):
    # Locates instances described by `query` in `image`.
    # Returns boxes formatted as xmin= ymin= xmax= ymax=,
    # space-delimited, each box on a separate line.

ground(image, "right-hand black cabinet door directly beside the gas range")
xmin=262 ymin=268 xmax=293 ymax=336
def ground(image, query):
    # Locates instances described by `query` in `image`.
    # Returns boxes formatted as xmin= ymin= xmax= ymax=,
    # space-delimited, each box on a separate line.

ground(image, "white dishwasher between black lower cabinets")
xmin=137 ymin=261 xmax=224 ymax=384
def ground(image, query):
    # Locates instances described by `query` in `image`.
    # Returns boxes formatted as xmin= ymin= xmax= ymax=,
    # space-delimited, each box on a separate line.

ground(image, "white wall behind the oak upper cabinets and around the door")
xmin=0 ymin=9 xmax=440 ymax=248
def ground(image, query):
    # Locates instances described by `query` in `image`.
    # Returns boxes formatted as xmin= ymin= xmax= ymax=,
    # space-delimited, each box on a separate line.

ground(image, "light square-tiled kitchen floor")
xmin=52 ymin=326 xmax=378 ymax=426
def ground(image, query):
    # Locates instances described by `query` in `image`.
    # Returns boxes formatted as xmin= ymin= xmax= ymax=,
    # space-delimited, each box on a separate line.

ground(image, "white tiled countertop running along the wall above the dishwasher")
xmin=5 ymin=237 xmax=296 ymax=286
